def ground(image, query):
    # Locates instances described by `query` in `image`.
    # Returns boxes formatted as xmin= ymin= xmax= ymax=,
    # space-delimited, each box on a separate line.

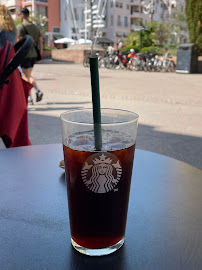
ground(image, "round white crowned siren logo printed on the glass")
xmin=81 ymin=152 xmax=122 ymax=193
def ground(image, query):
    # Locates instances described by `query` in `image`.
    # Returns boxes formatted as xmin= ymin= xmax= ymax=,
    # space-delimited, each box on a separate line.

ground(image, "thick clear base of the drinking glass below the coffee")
xmin=71 ymin=238 xmax=124 ymax=256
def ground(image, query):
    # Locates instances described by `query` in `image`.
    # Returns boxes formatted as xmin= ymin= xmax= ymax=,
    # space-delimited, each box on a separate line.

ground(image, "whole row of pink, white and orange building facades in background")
xmin=0 ymin=0 xmax=185 ymax=46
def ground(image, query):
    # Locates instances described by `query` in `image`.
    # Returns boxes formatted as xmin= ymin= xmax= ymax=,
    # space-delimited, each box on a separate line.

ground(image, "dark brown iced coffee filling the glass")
xmin=63 ymin=130 xmax=135 ymax=249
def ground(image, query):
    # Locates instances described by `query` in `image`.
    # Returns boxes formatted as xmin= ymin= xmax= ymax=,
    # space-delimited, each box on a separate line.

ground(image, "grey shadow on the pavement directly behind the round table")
xmin=29 ymin=113 xmax=202 ymax=169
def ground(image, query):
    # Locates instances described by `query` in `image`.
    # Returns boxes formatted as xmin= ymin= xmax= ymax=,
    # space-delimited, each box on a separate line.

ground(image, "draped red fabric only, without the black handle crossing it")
xmin=0 ymin=42 xmax=33 ymax=148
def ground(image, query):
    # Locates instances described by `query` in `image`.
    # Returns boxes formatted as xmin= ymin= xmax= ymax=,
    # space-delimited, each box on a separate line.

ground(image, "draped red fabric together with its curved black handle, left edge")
xmin=0 ymin=36 xmax=33 ymax=148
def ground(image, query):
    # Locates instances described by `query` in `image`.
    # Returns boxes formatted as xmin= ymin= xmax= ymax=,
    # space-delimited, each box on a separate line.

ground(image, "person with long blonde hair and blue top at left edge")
xmin=0 ymin=5 xmax=17 ymax=49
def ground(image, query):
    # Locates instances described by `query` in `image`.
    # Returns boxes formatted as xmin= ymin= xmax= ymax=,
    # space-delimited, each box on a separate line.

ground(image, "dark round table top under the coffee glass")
xmin=0 ymin=144 xmax=202 ymax=270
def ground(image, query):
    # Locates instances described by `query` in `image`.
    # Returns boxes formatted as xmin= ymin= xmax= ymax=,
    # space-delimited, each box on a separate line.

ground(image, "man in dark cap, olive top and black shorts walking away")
xmin=17 ymin=8 xmax=43 ymax=105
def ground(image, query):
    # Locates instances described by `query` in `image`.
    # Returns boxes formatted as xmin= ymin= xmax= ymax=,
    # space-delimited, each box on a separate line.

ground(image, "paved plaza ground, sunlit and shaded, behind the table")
xmin=0 ymin=60 xmax=202 ymax=169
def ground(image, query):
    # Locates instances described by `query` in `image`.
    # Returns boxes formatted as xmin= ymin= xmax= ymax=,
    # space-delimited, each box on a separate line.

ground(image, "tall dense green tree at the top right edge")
xmin=186 ymin=0 xmax=202 ymax=52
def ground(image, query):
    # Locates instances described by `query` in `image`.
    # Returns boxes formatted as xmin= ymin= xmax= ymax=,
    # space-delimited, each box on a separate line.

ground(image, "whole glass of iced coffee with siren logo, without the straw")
xmin=61 ymin=109 xmax=138 ymax=256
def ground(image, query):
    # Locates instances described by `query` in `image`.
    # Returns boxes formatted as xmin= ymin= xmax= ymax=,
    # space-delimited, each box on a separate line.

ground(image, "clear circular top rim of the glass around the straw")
xmin=60 ymin=108 xmax=139 ymax=126
